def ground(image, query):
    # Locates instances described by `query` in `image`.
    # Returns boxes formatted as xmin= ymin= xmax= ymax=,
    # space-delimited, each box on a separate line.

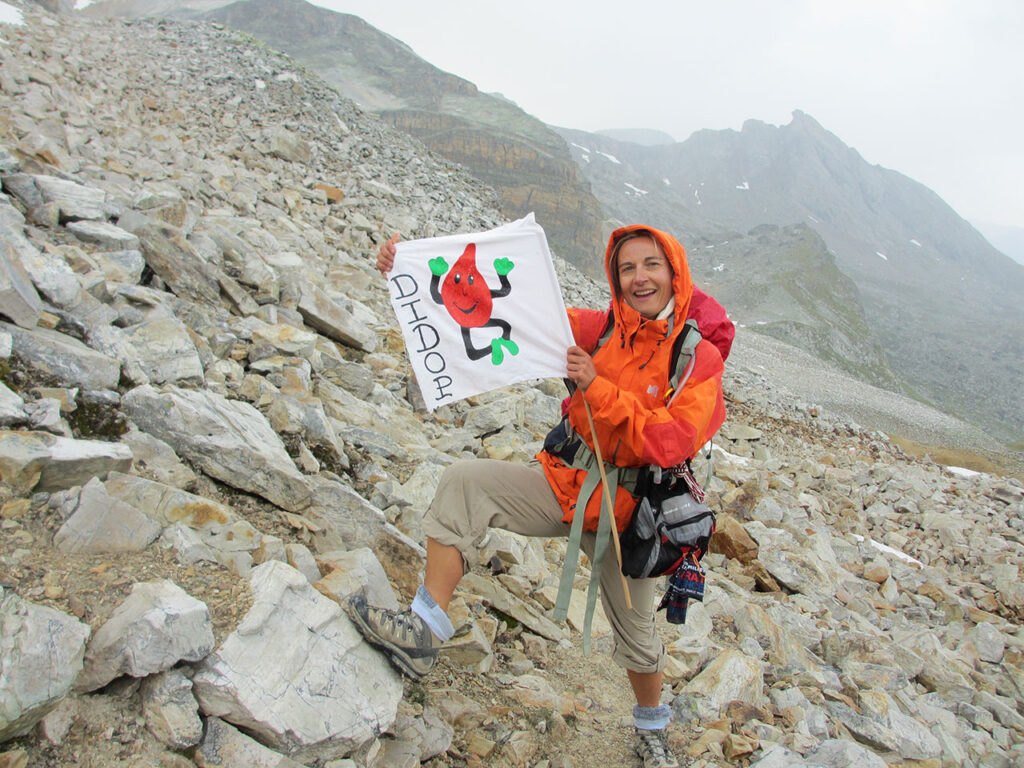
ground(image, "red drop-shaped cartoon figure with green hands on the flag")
xmin=430 ymin=243 xmax=519 ymax=366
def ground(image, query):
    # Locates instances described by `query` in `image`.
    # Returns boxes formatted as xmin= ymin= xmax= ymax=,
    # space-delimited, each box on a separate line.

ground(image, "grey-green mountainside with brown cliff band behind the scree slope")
xmin=83 ymin=0 xmax=606 ymax=279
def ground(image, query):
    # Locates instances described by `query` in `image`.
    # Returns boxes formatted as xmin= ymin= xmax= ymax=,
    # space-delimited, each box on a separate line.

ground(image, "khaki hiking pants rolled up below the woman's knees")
xmin=423 ymin=459 xmax=666 ymax=673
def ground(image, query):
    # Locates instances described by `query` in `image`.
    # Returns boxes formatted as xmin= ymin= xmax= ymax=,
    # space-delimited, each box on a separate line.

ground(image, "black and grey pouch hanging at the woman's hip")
xmin=620 ymin=471 xmax=715 ymax=579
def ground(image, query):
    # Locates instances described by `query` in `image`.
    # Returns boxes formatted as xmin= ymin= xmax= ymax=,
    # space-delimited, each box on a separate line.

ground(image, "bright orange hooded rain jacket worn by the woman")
xmin=537 ymin=225 xmax=732 ymax=531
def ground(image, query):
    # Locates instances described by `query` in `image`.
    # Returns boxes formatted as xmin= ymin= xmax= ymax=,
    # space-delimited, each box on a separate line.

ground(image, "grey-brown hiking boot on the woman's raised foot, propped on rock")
xmin=348 ymin=595 xmax=441 ymax=680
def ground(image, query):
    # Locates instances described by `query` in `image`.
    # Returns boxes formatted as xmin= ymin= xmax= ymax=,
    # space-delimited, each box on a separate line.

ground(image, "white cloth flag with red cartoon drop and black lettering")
xmin=388 ymin=213 xmax=574 ymax=411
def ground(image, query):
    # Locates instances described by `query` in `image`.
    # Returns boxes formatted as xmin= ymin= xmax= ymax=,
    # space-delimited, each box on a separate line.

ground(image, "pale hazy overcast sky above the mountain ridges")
xmin=311 ymin=0 xmax=1024 ymax=226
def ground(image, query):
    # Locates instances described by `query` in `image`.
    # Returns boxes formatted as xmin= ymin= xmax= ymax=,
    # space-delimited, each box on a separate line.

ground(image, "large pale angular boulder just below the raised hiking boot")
xmin=193 ymin=561 xmax=402 ymax=763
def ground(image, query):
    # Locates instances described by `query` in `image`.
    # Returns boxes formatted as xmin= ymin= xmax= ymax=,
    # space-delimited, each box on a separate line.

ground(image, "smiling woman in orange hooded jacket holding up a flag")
xmin=351 ymin=225 xmax=733 ymax=768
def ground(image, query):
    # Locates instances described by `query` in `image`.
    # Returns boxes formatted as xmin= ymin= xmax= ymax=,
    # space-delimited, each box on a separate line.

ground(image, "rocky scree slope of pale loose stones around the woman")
xmin=0 ymin=7 xmax=1024 ymax=768
